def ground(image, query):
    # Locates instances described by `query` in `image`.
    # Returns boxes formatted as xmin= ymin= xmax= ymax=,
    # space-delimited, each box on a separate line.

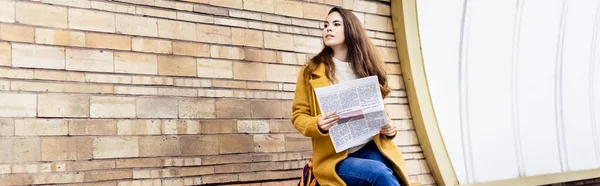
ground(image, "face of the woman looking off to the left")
xmin=323 ymin=12 xmax=346 ymax=47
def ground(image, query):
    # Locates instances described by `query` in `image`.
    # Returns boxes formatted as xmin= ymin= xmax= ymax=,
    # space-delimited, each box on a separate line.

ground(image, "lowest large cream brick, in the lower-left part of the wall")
xmin=93 ymin=137 xmax=139 ymax=159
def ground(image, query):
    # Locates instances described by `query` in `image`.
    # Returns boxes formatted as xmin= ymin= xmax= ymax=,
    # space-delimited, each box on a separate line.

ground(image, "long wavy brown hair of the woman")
xmin=304 ymin=7 xmax=390 ymax=98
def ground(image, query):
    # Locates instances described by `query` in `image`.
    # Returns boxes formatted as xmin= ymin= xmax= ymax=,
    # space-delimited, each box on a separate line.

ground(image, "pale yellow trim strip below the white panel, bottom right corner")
xmin=460 ymin=169 xmax=600 ymax=186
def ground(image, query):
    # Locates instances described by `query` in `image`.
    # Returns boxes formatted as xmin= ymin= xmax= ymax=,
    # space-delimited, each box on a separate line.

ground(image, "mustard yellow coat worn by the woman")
xmin=291 ymin=63 xmax=410 ymax=186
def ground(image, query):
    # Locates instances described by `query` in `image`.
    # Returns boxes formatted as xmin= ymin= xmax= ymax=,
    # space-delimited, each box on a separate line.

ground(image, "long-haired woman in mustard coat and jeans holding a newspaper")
xmin=291 ymin=8 xmax=409 ymax=186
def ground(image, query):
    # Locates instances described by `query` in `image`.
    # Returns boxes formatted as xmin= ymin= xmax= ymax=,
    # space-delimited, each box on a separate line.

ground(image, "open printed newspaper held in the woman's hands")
xmin=315 ymin=76 xmax=387 ymax=153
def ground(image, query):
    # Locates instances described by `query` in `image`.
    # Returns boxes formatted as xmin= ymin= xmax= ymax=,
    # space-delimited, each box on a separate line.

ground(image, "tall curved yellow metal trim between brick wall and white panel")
xmin=391 ymin=0 xmax=458 ymax=186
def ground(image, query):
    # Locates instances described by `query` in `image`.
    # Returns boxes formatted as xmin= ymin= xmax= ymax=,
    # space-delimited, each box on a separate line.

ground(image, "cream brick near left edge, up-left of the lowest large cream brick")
xmin=15 ymin=119 xmax=69 ymax=136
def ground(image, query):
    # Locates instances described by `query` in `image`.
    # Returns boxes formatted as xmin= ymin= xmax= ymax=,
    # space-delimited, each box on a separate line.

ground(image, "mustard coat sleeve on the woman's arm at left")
xmin=291 ymin=66 xmax=329 ymax=138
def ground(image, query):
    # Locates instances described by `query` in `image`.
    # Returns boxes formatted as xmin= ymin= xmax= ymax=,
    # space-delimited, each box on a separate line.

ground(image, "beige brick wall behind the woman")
xmin=0 ymin=0 xmax=434 ymax=186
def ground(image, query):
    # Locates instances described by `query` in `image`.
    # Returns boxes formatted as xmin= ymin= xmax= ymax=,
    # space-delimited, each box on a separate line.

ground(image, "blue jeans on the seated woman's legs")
xmin=336 ymin=141 xmax=400 ymax=186
